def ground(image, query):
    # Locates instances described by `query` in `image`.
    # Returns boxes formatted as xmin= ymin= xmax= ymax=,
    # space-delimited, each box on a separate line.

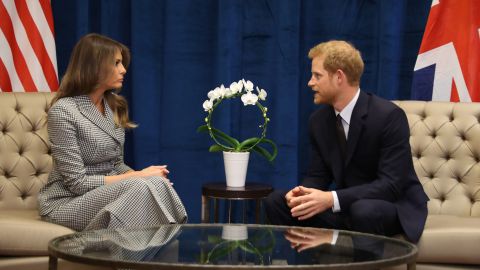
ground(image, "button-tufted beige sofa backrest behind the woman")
xmin=0 ymin=93 xmax=55 ymax=210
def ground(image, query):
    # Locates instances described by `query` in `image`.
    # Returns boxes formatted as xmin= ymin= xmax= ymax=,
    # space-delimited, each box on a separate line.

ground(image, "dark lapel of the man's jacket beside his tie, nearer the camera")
xmin=345 ymin=91 xmax=368 ymax=166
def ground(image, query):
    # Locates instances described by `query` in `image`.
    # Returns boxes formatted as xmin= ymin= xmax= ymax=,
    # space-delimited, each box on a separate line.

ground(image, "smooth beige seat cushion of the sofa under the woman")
xmin=0 ymin=210 xmax=74 ymax=256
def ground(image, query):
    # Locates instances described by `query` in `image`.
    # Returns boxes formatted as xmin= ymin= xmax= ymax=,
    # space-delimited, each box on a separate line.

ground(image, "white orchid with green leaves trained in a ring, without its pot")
xmin=197 ymin=79 xmax=277 ymax=162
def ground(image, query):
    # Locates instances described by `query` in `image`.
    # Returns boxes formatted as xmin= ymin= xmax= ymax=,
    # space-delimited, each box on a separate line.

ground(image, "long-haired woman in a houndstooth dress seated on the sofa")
xmin=39 ymin=34 xmax=187 ymax=231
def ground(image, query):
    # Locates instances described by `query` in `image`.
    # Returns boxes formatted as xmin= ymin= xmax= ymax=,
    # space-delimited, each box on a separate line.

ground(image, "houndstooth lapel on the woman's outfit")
xmin=75 ymin=96 xmax=120 ymax=142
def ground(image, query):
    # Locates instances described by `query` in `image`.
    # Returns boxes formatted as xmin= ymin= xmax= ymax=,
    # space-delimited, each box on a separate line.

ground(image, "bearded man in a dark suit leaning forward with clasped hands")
xmin=266 ymin=41 xmax=428 ymax=242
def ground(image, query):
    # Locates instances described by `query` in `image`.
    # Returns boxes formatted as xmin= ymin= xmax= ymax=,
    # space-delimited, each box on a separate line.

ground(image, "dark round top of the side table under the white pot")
xmin=202 ymin=182 xmax=273 ymax=199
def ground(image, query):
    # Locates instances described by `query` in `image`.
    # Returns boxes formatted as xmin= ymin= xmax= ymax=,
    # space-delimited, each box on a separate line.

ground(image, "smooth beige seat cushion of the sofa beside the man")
xmin=417 ymin=215 xmax=480 ymax=264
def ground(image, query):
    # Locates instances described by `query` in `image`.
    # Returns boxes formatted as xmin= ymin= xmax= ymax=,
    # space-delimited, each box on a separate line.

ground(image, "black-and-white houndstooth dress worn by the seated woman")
xmin=39 ymin=95 xmax=187 ymax=231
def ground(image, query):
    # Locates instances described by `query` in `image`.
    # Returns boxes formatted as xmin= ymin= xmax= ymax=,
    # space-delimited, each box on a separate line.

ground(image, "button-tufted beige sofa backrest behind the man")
xmin=395 ymin=101 xmax=480 ymax=217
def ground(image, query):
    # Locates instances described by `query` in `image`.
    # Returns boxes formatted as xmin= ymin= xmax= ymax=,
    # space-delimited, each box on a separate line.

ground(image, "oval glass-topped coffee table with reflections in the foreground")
xmin=48 ymin=224 xmax=417 ymax=269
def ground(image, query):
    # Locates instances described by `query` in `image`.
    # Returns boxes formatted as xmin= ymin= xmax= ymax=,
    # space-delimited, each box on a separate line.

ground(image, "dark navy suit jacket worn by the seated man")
xmin=303 ymin=92 xmax=428 ymax=242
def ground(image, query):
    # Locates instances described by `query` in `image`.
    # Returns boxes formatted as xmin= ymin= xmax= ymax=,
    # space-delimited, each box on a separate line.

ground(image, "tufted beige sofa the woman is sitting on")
xmin=0 ymin=93 xmax=102 ymax=270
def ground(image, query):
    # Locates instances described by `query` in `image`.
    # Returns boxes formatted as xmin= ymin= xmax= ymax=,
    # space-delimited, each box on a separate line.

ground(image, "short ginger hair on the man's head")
xmin=308 ymin=40 xmax=364 ymax=86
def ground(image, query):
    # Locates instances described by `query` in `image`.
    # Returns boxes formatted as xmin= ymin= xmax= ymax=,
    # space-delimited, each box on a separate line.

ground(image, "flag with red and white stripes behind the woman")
xmin=0 ymin=0 xmax=58 ymax=92
